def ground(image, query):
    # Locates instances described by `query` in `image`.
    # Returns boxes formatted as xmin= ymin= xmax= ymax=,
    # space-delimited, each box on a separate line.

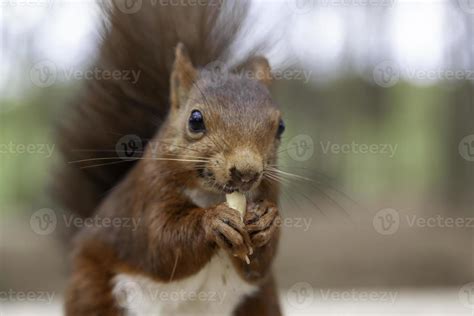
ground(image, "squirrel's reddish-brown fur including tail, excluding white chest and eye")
xmin=60 ymin=2 xmax=280 ymax=315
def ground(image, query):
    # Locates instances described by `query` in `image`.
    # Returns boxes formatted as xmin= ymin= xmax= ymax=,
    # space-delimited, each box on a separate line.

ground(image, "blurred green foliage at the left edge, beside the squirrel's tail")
xmin=0 ymin=86 xmax=75 ymax=212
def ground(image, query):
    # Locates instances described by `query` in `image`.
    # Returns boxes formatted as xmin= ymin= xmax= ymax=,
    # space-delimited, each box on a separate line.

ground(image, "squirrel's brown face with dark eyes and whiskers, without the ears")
xmin=174 ymin=75 xmax=284 ymax=193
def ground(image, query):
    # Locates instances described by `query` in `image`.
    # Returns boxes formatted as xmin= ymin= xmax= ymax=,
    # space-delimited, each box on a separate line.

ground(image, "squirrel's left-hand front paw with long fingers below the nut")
xmin=203 ymin=203 xmax=253 ymax=260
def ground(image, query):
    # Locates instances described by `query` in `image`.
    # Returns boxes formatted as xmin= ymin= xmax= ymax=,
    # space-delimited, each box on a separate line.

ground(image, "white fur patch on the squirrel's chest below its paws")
xmin=113 ymin=251 xmax=257 ymax=316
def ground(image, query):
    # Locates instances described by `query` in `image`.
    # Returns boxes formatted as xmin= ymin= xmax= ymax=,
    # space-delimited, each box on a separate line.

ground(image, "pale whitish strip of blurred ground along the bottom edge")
xmin=1 ymin=289 xmax=473 ymax=316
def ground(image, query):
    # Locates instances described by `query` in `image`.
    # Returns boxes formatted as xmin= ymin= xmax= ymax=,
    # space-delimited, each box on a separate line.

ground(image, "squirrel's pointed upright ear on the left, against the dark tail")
xmin=171 ymin=43 xmax=197 ymax=109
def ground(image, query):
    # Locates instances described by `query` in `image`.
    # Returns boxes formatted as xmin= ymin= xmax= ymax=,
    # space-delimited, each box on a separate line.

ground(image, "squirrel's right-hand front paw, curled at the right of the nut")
xmin=244 ymin=200 xmax=281 ymax=247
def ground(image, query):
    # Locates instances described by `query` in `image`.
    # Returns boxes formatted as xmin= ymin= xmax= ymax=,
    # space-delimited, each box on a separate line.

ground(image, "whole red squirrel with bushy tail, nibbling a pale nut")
xmin=55 ymin=0 xmax=285 ymax=316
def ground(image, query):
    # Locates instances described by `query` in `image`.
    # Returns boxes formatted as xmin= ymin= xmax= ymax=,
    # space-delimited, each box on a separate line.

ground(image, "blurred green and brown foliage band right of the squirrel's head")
xmin=274 ymin=78 xmax=474 ymax=207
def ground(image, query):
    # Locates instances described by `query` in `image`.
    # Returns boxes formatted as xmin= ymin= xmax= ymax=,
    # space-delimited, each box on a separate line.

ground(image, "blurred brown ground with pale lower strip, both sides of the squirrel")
xmin=0 ymin=205 xmax=474 ymax=316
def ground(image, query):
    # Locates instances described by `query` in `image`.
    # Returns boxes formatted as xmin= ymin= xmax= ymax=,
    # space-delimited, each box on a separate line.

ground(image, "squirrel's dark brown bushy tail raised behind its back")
xmin=54 ymin=0 xmax=249 ymax=217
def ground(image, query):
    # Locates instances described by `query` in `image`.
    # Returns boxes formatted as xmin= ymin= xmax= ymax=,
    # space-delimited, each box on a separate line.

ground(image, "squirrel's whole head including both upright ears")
xmin=167 ymin=44 xmax=285 ymax=193
